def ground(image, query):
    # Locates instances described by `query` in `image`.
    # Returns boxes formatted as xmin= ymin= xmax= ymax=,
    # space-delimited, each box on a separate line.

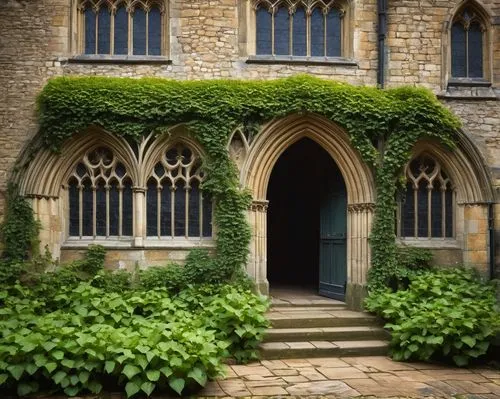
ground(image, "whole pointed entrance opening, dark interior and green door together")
xmin=267 ymin=138 xmax=347 ymax=300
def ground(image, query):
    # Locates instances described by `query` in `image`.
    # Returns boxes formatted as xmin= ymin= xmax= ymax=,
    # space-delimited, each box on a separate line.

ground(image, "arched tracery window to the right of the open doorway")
xmin=399 ymin=155 xmax=455 ymax=238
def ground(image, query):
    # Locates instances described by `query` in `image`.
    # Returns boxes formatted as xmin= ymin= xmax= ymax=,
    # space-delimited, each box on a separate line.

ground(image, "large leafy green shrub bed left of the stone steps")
xmin=0 ymin=282 xmax=267 ymax=397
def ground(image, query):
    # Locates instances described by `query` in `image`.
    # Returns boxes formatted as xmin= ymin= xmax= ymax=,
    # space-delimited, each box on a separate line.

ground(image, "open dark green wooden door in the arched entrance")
xmin=319 ymin=173 xmax=347 ymax=301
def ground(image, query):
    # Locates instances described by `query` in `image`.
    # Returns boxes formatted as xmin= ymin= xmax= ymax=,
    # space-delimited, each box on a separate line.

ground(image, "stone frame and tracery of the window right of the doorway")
xmin=396 ymin=151 xmax=458 ymax=241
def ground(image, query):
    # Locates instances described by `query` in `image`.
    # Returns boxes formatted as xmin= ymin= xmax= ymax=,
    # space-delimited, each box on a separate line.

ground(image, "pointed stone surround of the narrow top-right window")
xmin=442 ymin=0 xmax=494 ymax=88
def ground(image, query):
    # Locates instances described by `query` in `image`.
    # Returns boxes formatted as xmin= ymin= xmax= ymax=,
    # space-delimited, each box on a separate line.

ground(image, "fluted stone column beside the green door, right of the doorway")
xmin=346 ymin=203 xmax=375 ymax=309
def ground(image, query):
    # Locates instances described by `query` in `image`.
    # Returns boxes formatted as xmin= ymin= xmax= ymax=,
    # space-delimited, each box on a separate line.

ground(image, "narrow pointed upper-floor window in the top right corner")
xmin=451 ymin=7 xmax=486 ymax=78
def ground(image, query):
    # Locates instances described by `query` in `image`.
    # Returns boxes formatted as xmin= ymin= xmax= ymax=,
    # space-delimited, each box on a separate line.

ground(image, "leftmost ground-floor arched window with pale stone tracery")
xmin=68 ymin=147 xmax=133 ymax=238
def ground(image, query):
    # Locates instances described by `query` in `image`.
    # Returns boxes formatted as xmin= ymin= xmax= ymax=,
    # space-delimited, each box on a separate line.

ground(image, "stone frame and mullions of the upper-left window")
xmin=68 ymin=0 xmax=171 ymax=63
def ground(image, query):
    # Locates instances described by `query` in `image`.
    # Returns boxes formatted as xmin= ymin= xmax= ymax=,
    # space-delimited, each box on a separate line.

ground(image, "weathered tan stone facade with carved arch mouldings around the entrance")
xmin=0 ymin=0 xmax=500 ymax=306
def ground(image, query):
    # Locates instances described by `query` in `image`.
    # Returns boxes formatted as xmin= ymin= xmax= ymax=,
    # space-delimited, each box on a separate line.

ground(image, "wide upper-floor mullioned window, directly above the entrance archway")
xmin=254 ymin=0 xmax=345 ymax=57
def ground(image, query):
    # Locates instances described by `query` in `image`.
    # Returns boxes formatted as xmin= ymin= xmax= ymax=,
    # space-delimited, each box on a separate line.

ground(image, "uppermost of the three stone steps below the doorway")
xmin=267 ymin=309 xmax=378 ymax=328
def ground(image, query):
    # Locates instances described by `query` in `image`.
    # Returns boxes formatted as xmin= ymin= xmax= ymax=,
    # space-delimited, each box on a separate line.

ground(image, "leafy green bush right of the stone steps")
xmin=365 ymin=269 xmax=500 ymax=366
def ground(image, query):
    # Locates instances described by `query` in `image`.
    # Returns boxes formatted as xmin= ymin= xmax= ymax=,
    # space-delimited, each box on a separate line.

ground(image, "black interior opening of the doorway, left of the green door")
xmin=267 ymin=138 xmax=345 ymax=291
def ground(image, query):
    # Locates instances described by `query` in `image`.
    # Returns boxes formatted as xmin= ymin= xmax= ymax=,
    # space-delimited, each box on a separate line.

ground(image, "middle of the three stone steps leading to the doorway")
xmin=264 ymin=326 xmax=390 ymax=342
